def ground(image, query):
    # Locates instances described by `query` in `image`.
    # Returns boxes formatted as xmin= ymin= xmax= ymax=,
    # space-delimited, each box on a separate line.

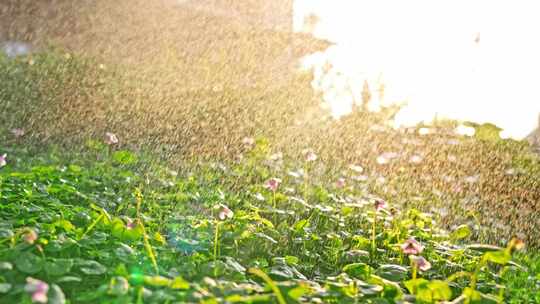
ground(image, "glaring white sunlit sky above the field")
xmin=294 ymin=0 xmax=540 ymax=138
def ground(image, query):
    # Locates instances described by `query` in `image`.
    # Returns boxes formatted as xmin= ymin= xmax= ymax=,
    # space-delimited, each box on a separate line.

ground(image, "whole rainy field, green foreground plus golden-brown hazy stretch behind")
xmin=0 ymin=38 xmax=540 ymax=303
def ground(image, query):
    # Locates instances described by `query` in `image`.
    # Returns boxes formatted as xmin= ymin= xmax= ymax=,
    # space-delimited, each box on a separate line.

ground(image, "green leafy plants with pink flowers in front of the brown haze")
xmin=0 ymin=138 xmax=540 ymax=303
